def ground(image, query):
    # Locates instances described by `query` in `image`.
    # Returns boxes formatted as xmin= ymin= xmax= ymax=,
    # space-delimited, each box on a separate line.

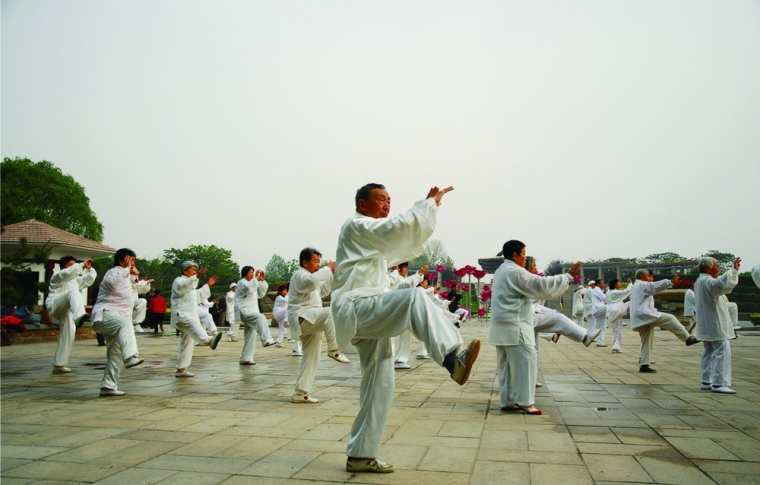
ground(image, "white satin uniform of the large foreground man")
xmin=331 ymin=199 xmax=462 ymax=458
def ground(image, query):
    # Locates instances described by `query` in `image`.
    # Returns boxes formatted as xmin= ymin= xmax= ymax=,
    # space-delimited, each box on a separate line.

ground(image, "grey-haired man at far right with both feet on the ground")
xmin=694 ymin=257 xmax=742 ymax=394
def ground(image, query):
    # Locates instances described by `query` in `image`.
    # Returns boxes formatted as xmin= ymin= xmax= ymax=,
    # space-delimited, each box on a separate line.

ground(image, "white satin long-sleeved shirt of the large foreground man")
xmin=331 ymin=199 xmax=438 ymax=348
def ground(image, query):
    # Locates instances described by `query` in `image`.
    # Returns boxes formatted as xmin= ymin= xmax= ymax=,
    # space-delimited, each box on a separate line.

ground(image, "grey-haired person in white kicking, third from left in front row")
xmin=171 ymin=261 xmax=222 ymax=378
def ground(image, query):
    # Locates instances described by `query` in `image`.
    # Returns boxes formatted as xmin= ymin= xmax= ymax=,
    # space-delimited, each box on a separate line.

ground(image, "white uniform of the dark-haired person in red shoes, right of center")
xmin=488 ymin=259 xmax=573 ymax=408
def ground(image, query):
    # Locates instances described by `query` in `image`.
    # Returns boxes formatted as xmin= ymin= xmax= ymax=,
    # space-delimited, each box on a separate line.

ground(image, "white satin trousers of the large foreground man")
xmin=347 ymin=288 xmax=462 ymax=458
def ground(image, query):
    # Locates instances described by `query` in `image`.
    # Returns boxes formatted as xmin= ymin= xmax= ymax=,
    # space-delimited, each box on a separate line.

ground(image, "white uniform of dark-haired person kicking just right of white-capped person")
xmin=235 ymin=278 xmax=274 ymax=362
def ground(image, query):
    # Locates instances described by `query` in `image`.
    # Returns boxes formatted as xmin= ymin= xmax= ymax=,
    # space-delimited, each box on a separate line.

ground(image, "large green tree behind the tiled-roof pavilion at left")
xmin=0 ymin=157 xmax=103 ymax=241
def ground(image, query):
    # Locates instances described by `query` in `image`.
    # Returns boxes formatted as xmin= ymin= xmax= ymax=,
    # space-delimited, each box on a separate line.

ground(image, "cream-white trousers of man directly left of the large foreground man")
xmin=295 ymin=308 xmax=338 ymax=396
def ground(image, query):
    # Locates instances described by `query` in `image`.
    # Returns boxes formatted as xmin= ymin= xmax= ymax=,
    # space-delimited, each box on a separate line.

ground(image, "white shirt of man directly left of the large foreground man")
xmin=288 ymin=266 xmax=333 ymax=323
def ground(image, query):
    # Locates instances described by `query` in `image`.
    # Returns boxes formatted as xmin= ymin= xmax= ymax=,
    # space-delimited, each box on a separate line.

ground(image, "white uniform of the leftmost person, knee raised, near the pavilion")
xmin=45 ymin=263 xmax=98 ymax=367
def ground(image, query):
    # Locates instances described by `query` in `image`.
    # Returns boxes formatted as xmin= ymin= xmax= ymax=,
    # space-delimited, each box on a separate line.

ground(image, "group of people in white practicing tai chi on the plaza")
xmin=46 ymin=183 xmax=752 ymax=473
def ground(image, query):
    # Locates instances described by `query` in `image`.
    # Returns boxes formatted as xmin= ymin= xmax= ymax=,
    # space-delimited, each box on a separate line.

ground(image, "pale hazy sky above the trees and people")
xmin=2 ymin=0 xmax=760 ymax=267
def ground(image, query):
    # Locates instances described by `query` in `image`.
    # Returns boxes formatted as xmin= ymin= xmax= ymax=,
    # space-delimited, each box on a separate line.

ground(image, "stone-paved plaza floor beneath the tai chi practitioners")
xmin=2 ymin=322 xmax=760 ymax=485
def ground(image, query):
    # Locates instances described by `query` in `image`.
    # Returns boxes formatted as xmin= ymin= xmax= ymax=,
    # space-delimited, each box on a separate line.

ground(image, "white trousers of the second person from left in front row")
xmin=92 ymin=310 xmax=138 ymax=390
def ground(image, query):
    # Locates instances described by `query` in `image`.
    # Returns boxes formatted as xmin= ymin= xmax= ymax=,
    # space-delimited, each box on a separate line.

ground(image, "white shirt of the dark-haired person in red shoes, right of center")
xmin=488 ymin=259 xmax=573 ymax=346
